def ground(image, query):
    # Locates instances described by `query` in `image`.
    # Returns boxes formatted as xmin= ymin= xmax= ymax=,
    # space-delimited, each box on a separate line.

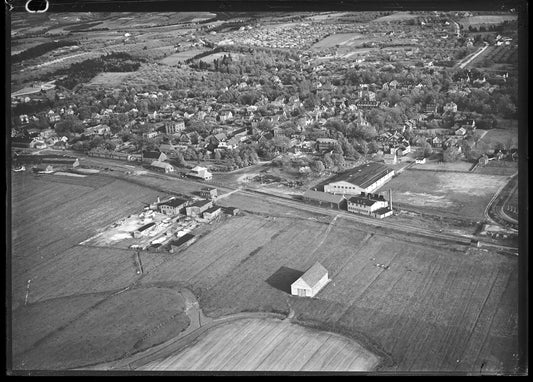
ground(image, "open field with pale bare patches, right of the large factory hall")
xmin=378 ymin=169 xmax=507 ymax=220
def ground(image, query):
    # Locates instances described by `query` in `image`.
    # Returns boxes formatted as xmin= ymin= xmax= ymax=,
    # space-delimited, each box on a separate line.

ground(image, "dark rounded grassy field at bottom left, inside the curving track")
xmin=13 ymin=287 xmax=189 ymax=370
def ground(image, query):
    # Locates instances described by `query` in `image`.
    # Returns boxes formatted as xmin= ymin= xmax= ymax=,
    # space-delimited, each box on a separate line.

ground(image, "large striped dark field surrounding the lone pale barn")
xmin=136 ymin=215 xmax=518 ymax=372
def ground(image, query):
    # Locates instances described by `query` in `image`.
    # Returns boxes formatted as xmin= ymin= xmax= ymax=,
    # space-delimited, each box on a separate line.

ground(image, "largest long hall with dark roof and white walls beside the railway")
xmin=324 ymin=162 xmax=394 ymax=195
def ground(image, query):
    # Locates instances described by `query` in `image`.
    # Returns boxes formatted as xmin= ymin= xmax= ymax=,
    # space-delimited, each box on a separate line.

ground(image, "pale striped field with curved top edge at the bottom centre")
xmin=140 ymin=319 xmax=378 ymax=371
